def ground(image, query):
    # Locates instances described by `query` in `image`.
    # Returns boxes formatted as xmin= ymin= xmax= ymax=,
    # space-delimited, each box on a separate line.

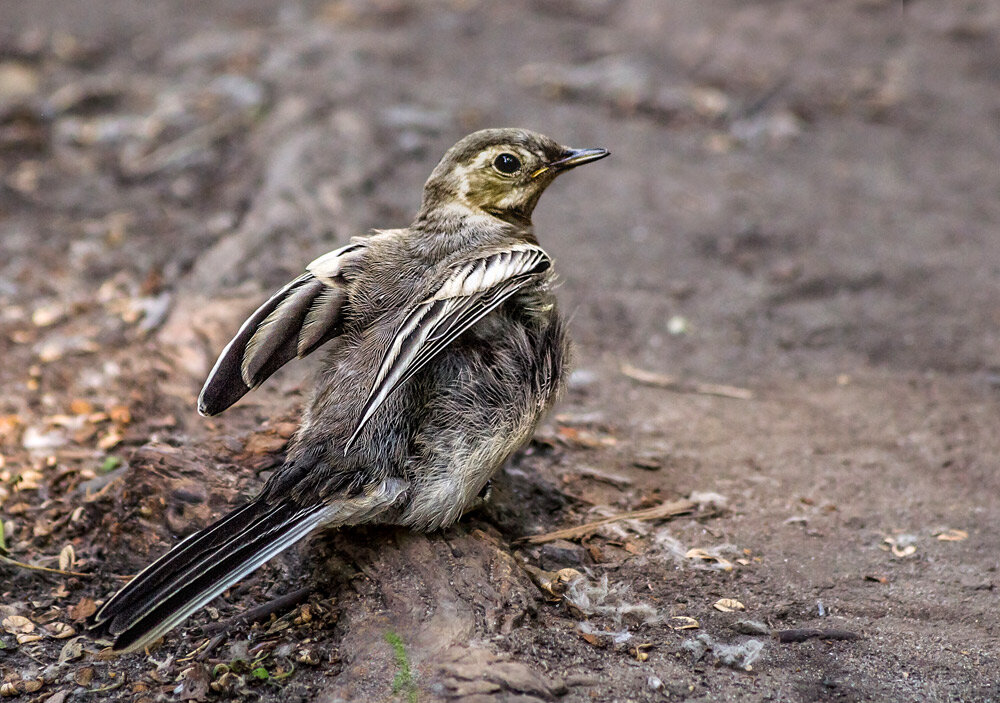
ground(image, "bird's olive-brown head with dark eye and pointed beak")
xmin=421 ymin=129 xmax=609 ymax=224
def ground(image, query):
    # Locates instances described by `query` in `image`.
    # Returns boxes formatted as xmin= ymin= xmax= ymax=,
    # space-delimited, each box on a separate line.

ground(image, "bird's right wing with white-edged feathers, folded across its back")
xmin=344 ymin=244 xmax=552 ymax=452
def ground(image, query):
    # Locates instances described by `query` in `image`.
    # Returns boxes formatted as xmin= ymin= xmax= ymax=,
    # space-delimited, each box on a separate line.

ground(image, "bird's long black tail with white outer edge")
xmin=90 ymin=500 xmax=327 ymax=652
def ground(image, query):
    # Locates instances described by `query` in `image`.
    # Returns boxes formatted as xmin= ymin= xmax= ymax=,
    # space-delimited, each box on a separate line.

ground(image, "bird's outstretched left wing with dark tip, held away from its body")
xmin=198 ymin=239 xmax=367 ymax=415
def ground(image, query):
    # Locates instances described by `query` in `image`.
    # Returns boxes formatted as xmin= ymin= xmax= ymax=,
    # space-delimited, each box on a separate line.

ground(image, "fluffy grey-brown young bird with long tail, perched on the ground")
xmin=89 ymin=128 xmax=609 ymax=653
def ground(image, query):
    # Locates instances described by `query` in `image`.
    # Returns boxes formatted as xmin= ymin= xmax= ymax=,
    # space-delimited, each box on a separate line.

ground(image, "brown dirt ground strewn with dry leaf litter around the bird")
xmin=0 ymin=0 xmax=1000 ymax=703
